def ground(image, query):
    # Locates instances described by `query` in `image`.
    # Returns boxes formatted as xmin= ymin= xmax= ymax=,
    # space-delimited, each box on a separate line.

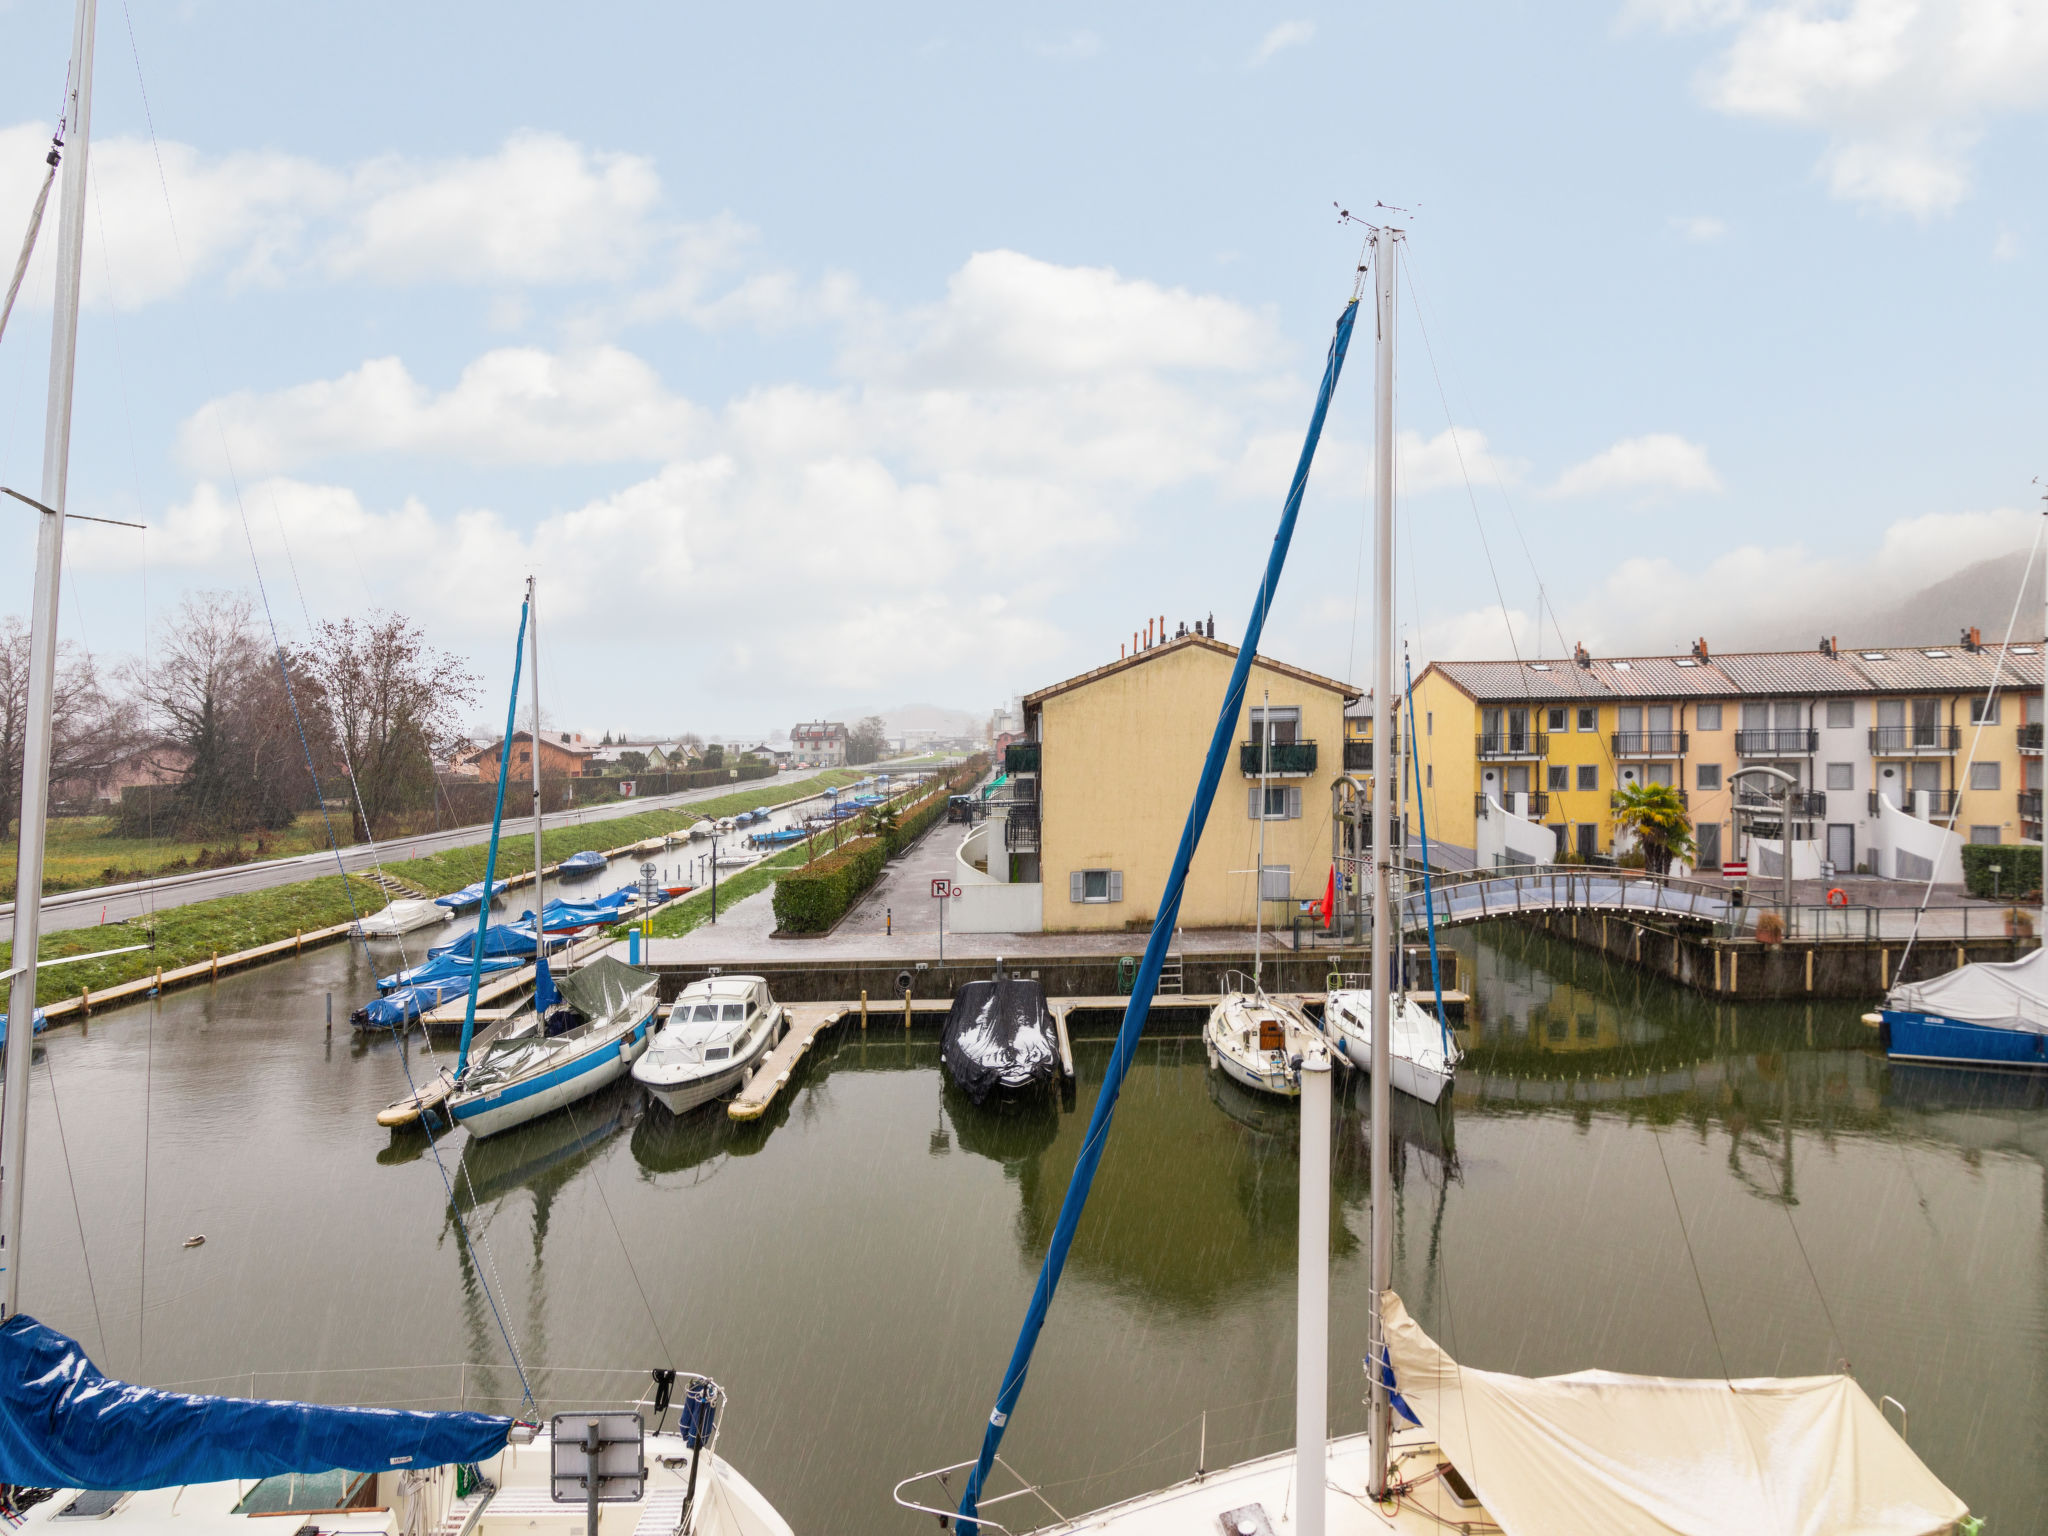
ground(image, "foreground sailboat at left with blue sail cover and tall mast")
xmin=0 ymin=0 xmax=791 ymax=1536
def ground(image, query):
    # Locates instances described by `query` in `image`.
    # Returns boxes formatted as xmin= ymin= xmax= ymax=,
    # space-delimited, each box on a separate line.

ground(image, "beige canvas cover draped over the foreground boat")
xmin=1382 ymin=1290 xmax=1968 ymax=1536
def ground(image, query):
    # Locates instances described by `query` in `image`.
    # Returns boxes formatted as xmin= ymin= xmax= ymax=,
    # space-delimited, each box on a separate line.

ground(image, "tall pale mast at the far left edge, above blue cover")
xmin=0 ymin=0 xmax=98 ymax=1317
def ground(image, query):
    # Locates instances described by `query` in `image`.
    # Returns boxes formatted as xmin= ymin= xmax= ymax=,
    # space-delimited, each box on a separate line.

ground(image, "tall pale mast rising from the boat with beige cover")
xmin=1368 ymin=227 xmax=1401 ymax=1499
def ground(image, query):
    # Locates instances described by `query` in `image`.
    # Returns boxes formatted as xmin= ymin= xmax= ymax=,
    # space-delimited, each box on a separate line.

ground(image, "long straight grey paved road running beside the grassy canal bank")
xmin=0 ymin=770 xmax=913 ymax=932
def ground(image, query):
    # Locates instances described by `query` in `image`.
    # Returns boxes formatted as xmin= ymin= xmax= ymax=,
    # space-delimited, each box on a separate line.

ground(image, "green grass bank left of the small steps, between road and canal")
xmin=0 ymin=874 xmax=385 ymax=1006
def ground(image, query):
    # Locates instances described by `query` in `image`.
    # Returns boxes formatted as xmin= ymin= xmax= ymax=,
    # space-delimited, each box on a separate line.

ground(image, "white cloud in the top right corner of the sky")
xmin=1622 ymin=0 xmax=2048 ymax=217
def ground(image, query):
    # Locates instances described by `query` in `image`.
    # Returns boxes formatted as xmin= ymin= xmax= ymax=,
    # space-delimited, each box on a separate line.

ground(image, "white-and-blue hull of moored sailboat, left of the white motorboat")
xmin=449 ymin=954 xmax=659 ymax=1137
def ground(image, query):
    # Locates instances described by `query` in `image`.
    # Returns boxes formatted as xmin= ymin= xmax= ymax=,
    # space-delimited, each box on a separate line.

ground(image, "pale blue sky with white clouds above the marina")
xmin=0 ymin=0 xmax=2048 ymax=733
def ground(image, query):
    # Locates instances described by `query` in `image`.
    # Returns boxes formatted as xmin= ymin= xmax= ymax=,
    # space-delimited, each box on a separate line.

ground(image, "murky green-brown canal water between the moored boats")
xmin=8 ymin=930 xmax=2048 ymax=1532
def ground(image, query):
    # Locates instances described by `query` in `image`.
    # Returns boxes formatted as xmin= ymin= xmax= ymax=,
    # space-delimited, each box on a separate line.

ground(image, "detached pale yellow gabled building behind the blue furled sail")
xmin=1008 ymin=635 xmax=1358 ymax=932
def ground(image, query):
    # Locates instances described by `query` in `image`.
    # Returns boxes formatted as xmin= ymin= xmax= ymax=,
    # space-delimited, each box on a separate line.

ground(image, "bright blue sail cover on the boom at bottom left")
xmin=0 ymin=1313 xmax=512 ymax=1489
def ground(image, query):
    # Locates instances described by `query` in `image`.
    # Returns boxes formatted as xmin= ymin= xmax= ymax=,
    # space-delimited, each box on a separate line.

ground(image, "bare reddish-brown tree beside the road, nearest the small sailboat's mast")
xmin=307 ymin=612 xmax=477 ymax=838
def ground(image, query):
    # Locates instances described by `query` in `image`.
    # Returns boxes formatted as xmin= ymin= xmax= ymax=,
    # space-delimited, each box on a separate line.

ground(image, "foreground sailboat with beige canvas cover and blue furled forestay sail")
xmin=895 ymin=227 xmax=1968 ymax=1536
